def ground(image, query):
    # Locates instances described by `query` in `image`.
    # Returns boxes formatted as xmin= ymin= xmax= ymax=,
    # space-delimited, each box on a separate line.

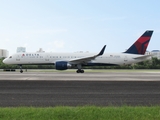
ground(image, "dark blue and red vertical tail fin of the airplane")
xmin=124 ymin=30 xmax=153 ymax=55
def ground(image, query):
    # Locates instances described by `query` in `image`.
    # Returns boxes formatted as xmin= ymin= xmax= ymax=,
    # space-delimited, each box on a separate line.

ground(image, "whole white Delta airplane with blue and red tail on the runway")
xmin=3 ymin=30 xmax=153 ymax=73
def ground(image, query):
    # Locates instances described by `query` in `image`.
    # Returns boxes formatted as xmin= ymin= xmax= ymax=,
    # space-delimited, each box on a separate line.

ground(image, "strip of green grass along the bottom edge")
xmin=0 ymin=106 xmax=160 ymax=120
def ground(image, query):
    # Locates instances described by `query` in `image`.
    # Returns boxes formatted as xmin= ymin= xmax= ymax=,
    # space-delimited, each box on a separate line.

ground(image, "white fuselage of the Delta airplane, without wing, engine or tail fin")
xmin=3 ymin=53 xmax=150 ymax=65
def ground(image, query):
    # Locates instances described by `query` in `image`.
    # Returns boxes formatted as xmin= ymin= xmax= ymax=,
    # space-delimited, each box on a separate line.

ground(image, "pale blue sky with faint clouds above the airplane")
xmin=0 ymin=0 xmax=160 ymax=54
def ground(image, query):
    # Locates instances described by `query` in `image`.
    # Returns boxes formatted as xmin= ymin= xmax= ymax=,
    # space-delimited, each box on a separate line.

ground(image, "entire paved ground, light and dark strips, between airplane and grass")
xmin=0 ymin=72 xmax=160 ymax=107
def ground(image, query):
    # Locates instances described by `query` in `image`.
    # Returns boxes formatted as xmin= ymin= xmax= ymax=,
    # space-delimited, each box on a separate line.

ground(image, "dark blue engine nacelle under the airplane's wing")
xmin=55 ymin=61 xmax=72 ymax=70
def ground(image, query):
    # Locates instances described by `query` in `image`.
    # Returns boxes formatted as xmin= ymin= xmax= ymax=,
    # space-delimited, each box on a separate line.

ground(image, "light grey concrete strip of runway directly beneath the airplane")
xmin=0 ymin=70 xmax=160 ymax=81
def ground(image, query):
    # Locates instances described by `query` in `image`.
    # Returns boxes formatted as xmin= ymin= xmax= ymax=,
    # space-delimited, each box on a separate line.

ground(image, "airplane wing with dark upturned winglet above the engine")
xmin=69 ymin=45 xmax=106 ymax=64
